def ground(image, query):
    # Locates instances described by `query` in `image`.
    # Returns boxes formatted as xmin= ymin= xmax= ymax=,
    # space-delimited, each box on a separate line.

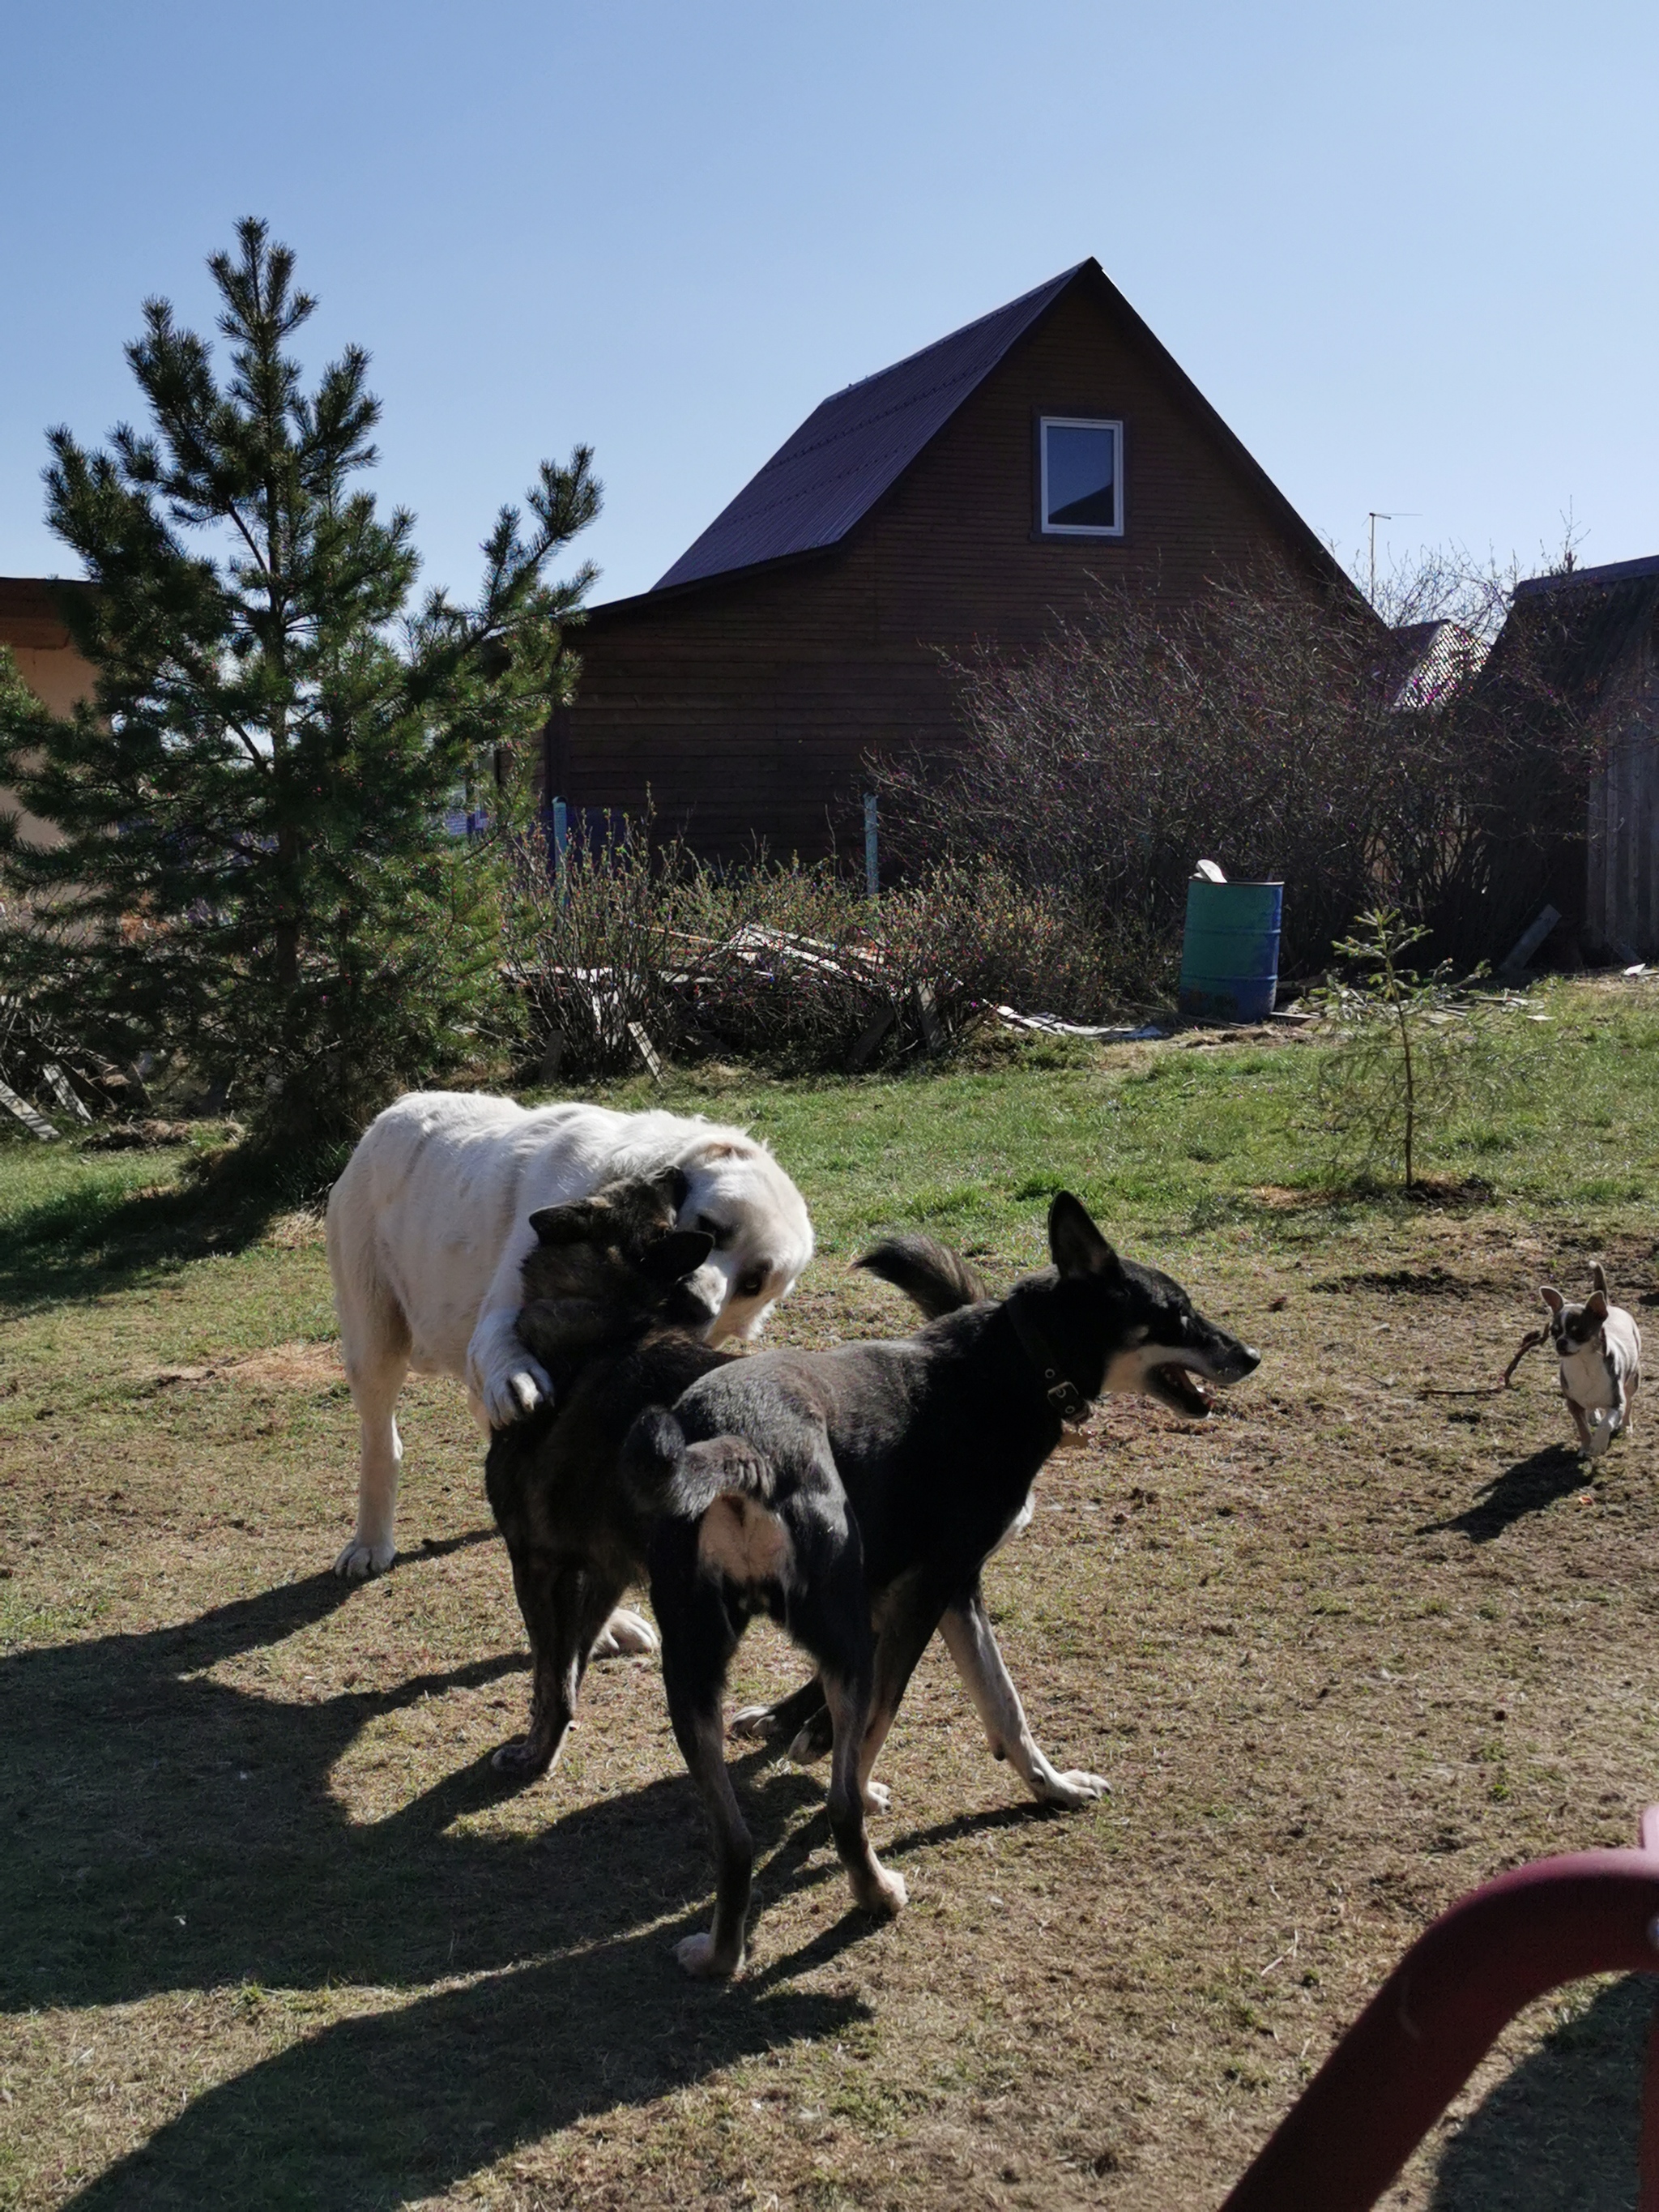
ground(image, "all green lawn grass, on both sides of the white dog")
xmin=0 ymin=984 xmax=1659 ymax=1312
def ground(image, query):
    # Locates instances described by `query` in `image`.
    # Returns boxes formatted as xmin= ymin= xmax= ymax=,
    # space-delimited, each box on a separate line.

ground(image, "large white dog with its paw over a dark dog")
xmin=327 ymin=1091 xmax=812 ymax=1619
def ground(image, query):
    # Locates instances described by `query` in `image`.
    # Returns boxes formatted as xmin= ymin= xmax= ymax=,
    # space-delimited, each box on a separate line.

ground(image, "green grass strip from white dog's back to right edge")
xmin=526 ymin=982 xmax=1659 ymax=1252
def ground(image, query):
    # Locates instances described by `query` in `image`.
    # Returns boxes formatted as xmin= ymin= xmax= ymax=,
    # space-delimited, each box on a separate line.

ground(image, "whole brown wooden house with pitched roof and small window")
xmin=544 ymin=261 xmax=1351 ymax=856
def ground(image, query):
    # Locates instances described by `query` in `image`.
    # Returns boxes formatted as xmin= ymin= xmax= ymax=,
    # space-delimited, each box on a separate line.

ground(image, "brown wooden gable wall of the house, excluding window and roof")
xmin=566 ymin=288 xmax=1336 ymax=856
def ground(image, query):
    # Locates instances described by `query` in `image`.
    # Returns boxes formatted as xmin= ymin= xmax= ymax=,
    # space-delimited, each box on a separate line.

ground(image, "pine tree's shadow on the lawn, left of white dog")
xmin=0 ymin=1146 xmax=345 ymax=1314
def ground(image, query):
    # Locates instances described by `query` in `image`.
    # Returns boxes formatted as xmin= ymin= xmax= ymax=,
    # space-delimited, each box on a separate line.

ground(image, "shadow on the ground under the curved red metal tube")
xmin=1429 ymin=1973 xmax=1653 ymax=2212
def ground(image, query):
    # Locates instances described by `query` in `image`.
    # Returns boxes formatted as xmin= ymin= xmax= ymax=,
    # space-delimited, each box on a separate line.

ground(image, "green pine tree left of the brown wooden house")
xmin=0 ymin=219 xmax=599 ymax=1134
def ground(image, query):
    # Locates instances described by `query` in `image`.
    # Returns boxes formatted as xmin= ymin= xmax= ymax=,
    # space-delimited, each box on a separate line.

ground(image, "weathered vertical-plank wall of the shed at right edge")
xmin=1584 ymin=610 xmax=1659 ymax=960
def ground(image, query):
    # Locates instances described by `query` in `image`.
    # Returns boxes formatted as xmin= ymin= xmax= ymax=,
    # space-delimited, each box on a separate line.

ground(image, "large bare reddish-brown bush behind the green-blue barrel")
xmin=872 ymin=562 xmax=1584 ymax=1015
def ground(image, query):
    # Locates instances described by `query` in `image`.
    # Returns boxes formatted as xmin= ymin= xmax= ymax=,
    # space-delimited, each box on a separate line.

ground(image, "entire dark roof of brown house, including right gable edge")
xmin=628 ymin=257 xmax=1351 ymax=615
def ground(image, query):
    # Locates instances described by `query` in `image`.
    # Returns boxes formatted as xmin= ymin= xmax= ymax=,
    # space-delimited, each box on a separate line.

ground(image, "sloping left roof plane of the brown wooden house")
xmin=653 ymin=261 xmax=1090 ymax=591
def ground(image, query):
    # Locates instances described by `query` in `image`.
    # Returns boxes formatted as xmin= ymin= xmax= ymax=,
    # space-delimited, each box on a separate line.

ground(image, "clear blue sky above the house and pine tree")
xmin=0 ymin=0 xmax=1659 ymax=600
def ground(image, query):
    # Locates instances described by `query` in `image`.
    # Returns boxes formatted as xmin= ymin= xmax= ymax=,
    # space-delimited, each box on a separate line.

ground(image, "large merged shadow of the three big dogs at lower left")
xmin=0 ymin=1575 xmax=898 ymax=2212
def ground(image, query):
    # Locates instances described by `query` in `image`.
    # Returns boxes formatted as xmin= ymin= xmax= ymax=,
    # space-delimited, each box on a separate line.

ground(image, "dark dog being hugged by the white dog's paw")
xmin=484 ymin=1168 xmax=730 ymax=1781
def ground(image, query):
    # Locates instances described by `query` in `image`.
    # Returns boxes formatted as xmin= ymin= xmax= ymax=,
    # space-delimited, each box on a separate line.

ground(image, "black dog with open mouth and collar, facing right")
xmin=621 ymin=1192 xmax=1260 ymax=1975
